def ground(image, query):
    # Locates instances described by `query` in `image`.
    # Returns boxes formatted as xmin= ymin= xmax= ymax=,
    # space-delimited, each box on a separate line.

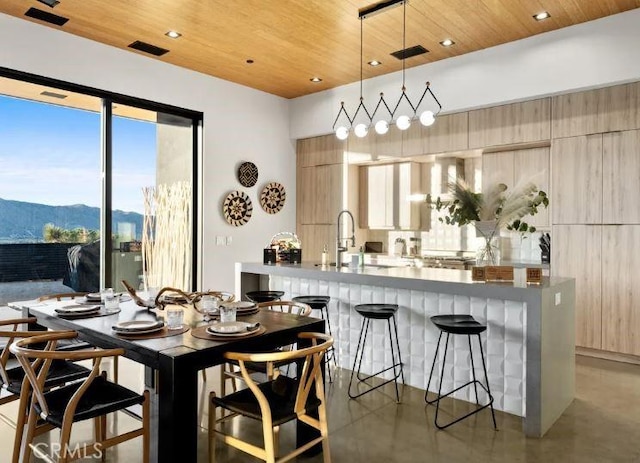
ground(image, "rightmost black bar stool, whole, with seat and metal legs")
xmin=424 ymin=315 xmax=498 ymax=429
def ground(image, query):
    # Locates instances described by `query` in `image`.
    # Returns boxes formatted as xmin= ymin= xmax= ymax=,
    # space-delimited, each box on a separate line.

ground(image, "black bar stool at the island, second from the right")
xmin=348 ymin=304 xmax=404 ymax=403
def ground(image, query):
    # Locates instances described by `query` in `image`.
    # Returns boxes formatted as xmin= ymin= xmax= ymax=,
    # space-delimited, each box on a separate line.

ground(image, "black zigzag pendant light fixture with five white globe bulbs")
xmin=333 ymin=0 xmax=442 ymax=140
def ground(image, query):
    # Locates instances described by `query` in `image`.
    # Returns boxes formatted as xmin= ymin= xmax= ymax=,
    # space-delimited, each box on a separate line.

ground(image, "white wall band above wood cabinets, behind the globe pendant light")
xmin=290 ymin=9 xmax=640 ymax=139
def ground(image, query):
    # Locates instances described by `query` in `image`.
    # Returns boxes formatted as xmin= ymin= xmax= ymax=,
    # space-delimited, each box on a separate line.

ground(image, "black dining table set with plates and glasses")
xmin=14 ymin=301 xmax=325 ymax=463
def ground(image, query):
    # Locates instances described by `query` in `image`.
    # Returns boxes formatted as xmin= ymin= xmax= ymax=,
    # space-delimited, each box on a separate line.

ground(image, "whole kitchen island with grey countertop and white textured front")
xmin=236 ymin=263 xmax=575 ymax=437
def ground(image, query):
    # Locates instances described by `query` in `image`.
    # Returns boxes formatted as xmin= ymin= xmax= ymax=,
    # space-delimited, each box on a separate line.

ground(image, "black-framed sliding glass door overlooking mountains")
xmin=0 ymin=69 xmax=201 ymax=305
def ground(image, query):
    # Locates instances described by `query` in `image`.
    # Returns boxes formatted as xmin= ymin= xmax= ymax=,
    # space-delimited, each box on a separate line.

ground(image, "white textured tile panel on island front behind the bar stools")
xmin=269 ymin=276 xmax=526 ymax=416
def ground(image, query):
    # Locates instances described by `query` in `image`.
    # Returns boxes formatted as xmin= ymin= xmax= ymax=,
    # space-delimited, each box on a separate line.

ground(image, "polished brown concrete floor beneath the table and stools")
xmin=0 ymin=356 xmax=640 ymax=463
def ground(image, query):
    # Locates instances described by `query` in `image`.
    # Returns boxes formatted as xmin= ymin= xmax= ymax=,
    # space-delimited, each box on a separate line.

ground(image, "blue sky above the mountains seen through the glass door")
xmin=0 ymin=95 xmax=156 ymax=213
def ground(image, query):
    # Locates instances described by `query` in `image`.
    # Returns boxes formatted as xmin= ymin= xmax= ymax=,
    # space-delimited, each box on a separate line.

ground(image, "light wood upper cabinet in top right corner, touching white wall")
xmin=552 ymin=82 xmax=640 ymax=138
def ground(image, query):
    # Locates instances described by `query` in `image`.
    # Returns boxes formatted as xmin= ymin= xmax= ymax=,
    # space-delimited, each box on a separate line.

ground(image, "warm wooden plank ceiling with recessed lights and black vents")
xmin=0 ymin=0 xmax=640 ymax=98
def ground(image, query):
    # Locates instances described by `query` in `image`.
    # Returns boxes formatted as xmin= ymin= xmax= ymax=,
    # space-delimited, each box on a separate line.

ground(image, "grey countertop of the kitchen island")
xmin=236 ymin=262 xmax=570 ymax=301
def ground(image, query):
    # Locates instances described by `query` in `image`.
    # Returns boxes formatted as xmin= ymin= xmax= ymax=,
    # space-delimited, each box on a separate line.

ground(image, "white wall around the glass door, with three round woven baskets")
xmin=0 ymin=14 xmax=296 ymax=290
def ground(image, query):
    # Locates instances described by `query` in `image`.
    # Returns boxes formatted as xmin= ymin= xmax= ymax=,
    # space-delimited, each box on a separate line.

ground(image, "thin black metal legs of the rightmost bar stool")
xmin=425 ymin=331 xmax=498 ymax=429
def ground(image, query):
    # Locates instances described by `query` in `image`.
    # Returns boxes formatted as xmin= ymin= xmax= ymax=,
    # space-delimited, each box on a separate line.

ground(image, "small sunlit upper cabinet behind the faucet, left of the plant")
xmin=358 ymin=162 xmax=421 ymax=230
